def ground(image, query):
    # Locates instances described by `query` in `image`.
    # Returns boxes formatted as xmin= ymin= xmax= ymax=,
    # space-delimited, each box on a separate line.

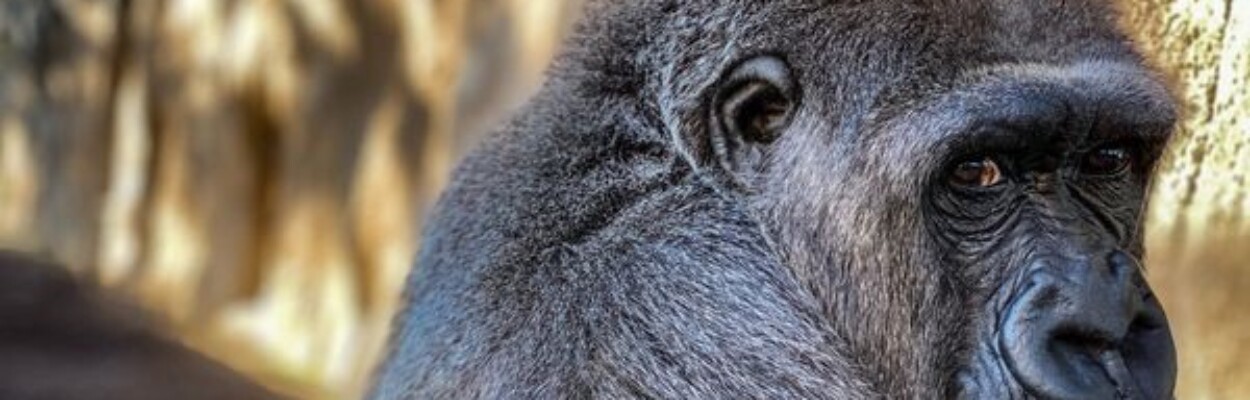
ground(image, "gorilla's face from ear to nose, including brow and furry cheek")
xmin=711 ymin=38 xmax=1175 ymax=399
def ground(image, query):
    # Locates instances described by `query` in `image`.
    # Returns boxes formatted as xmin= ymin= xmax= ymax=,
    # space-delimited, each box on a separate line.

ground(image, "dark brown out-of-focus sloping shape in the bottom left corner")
xmin=0 ymin=251 xmax=279 ymax=400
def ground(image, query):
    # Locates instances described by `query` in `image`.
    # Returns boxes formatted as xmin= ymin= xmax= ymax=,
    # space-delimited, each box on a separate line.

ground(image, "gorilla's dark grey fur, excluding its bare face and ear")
xmin=373 ymin=0 xmax=1171 ymax=399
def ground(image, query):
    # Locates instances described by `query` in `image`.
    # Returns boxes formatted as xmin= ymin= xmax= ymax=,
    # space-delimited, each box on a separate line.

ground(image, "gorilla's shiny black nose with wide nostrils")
xmin=999 ymin=251 xmax=1176 ymax=399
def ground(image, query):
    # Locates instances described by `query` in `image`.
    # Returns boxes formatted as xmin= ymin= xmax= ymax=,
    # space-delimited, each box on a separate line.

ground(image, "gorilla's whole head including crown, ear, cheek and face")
xmin=574 ymin=0 xmax=1176 ymax=399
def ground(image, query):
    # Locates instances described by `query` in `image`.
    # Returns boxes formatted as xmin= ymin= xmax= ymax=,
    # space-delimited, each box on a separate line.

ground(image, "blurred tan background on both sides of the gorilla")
xmin=0 ymin=0 xmax=1250 ymax=399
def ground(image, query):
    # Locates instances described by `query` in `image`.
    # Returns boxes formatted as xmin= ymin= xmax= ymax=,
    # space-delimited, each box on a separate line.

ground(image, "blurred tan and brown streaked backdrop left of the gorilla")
xmin=0 ymin=0 xmax=576 ymax=398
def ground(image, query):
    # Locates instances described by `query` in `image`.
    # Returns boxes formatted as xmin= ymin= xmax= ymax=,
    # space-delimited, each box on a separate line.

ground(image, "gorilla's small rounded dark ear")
xmin=709 ymin=55 xmax=799 ymax=183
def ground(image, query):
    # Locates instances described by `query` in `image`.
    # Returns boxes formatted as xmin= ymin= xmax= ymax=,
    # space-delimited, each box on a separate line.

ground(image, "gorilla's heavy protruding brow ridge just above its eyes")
xmin=864 ymin=60 xmax=1176 ymax=149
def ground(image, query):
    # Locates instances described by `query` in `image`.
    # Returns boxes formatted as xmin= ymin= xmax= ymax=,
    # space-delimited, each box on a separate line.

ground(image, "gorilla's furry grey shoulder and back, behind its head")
xmin=373 ymin=1 xmax=866 ymax=399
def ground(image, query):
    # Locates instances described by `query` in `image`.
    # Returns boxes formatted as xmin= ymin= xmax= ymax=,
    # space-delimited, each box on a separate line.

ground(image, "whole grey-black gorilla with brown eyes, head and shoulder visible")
xmin=370 ymin=0 xmax=1176 ymax=399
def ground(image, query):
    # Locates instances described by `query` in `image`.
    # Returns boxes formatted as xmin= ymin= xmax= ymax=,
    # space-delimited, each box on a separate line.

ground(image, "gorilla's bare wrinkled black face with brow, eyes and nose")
xmin=900 ymin=63 xmax=1175 ymax=399
